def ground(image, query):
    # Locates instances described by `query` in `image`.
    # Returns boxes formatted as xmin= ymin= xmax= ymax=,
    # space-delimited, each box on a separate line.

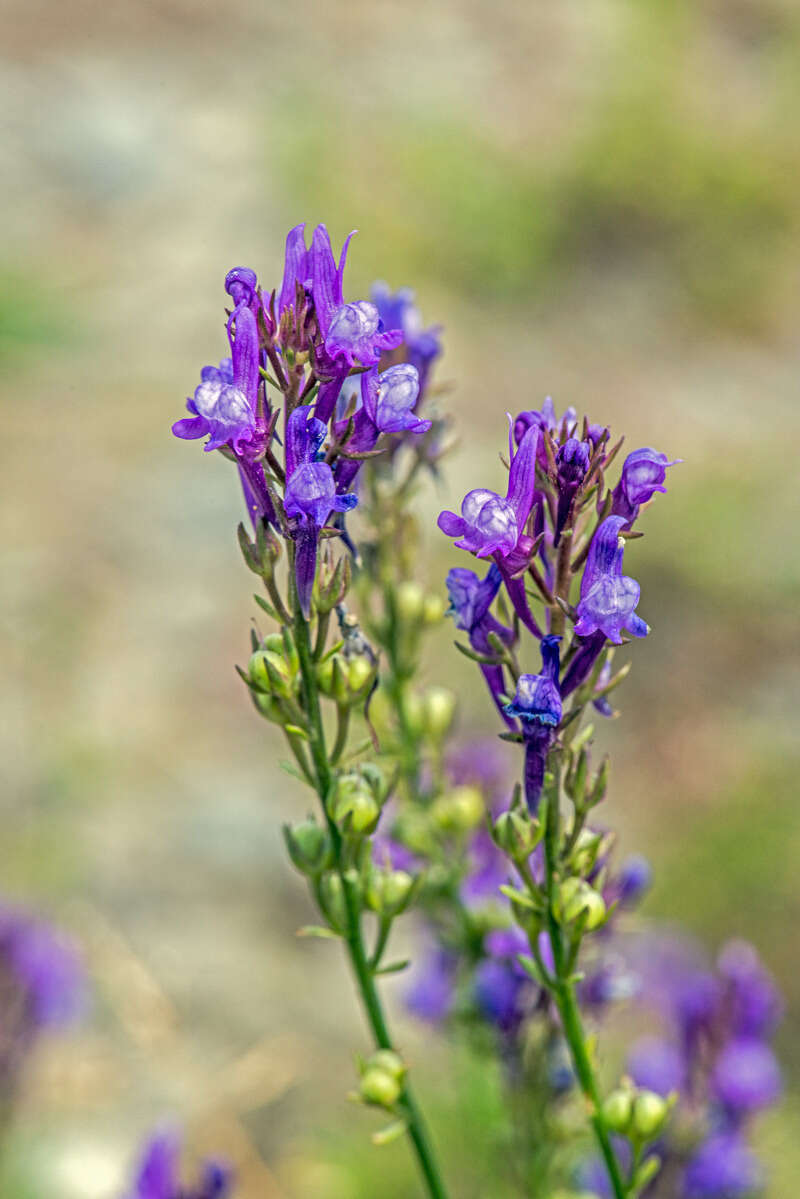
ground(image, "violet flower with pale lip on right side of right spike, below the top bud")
xmin=575 ymin=517 xmax=650 ymax=645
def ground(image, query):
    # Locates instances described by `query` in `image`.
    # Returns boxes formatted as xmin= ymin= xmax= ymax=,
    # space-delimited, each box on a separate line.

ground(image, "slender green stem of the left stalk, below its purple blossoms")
xmin=294 ymin=603 xmax=447 ymax=1199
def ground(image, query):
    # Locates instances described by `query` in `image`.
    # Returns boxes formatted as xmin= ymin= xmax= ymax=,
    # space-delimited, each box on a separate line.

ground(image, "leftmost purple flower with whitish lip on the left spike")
xmin=173 ymin=266 xmax=264 ymax=457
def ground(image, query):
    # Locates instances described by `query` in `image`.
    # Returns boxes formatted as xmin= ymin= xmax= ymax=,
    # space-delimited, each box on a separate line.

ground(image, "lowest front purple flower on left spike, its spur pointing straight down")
xmin=283 ymin=404 xmax=357 ymax=619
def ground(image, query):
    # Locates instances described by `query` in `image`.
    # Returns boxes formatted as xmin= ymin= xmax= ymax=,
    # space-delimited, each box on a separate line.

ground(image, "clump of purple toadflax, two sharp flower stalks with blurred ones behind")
xmin=172 ymin=225 xmax=778 ymax=1199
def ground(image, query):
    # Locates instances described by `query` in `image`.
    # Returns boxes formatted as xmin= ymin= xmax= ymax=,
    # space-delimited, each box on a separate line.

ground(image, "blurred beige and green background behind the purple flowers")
xmin=0 ymin=0 xmax=800 ymax=1199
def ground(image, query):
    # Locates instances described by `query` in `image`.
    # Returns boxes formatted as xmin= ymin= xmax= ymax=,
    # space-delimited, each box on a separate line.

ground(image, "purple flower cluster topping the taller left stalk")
xmin=173 ymin=224 xmax=439 ymax=617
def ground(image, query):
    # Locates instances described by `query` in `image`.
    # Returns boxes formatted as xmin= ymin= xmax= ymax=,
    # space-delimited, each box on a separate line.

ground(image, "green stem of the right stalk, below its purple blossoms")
xmin=545 ymin=770 xmax=627 ymax=1199
